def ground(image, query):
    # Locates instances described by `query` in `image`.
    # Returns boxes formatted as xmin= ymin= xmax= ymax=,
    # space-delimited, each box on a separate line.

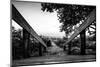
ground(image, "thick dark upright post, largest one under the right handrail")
xmin=80 ymin=30 xmax=86 ymax=55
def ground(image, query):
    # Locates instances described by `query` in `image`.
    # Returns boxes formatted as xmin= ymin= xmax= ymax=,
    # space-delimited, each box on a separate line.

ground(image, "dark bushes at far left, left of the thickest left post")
xmin=12 ymin=27 xmax=23 ymax=59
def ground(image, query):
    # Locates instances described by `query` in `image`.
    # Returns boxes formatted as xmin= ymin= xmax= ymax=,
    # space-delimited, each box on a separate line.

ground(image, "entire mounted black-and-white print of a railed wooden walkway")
xmin=10 ymin=0 xmax=96 ymax=67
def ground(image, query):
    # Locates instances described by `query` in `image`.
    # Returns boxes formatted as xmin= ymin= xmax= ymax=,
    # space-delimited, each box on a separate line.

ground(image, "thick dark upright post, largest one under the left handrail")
xmin=23 ymin=29 xmax=30 ymax=58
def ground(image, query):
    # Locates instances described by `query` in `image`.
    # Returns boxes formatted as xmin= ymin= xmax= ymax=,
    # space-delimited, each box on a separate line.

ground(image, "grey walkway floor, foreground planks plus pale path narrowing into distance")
xmin=13 ymin=40 xmax=96 ymax=66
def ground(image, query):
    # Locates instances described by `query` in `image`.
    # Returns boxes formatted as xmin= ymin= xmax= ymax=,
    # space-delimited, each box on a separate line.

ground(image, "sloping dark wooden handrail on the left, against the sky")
xmin=12 ymin=5 xmax=47 ymax=47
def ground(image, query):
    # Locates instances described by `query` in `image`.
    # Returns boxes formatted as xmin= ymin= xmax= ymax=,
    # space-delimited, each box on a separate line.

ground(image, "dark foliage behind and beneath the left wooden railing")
xmin=12 ymin=27 xmax=51 ymax=60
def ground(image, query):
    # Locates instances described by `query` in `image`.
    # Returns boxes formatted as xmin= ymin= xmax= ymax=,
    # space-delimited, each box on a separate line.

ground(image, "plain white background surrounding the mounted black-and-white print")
xmin=0 ymin=0 xmax=100 ymax=67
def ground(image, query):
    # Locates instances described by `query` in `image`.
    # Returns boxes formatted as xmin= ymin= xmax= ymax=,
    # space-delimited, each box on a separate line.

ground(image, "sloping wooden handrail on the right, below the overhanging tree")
xmin=63 ymin=9 xmax=96 ymax=45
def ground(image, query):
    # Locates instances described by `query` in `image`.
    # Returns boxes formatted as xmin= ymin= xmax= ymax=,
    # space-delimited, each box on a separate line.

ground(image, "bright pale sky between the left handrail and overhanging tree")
xmin=12 ymin=2 xmax=65 ymax=38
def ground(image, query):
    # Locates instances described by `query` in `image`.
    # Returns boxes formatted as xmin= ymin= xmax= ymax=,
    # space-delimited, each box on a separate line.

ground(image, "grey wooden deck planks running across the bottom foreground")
xmin=13 ymin=55 xmax=96 ymax=66
